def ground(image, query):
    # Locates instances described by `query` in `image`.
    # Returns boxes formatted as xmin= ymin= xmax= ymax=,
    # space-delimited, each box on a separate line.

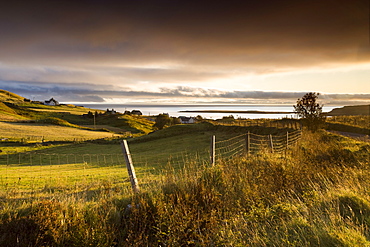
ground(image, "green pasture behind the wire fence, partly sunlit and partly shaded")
xmin=0 ymin=123 xmax=258 ymax=197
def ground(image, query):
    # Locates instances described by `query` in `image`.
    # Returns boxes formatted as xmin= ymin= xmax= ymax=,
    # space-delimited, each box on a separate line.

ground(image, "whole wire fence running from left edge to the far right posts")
xmin=0 ymin=131 xmax=301 ymax=196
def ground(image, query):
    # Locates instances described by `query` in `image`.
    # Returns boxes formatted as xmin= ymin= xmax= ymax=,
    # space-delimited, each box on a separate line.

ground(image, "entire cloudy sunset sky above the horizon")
xmin=0 ymin=0 xmax=370 ymax=105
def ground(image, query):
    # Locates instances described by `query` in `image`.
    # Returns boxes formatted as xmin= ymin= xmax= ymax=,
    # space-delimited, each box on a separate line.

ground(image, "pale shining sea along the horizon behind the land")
xmin=83 ymin=104 xmax=341 ymax=120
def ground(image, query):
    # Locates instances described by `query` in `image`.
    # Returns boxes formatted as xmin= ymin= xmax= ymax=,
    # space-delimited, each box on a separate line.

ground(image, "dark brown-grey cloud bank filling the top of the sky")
xmin=0 ymin=0 xmax=369 ymax=66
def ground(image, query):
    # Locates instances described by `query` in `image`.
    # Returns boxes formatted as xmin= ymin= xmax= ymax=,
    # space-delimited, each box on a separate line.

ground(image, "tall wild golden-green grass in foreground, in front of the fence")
xmin=0 ymin=132 xmax=370 ymax=246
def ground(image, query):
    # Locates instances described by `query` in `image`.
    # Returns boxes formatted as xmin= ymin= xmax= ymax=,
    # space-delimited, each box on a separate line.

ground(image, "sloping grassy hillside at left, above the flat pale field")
xmin=0 ymin=90 xmax=154 ymax=136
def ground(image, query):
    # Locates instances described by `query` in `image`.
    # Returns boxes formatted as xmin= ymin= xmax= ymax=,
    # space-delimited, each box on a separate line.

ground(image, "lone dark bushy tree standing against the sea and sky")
xmin=293 ymin=93 xmax=325 ymax=131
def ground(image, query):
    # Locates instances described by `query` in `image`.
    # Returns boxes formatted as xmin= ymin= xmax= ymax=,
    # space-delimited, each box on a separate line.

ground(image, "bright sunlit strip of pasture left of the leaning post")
xmin=0 ymin=163 xmax=134 ymax=197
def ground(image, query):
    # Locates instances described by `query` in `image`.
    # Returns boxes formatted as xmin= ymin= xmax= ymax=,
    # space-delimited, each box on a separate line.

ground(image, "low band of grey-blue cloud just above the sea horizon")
xmin=0 ymin=81 xmax=370 ymax=105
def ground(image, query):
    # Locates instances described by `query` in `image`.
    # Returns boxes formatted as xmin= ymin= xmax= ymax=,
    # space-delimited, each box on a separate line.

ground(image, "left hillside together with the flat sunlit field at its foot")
xmin=0 ymin=90 xmax=154 ymax=144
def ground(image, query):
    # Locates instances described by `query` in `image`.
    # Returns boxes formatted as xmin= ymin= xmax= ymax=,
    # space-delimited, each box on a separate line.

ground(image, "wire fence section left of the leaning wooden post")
xmin=0 ymin=153 xmax=127 ymax=197
